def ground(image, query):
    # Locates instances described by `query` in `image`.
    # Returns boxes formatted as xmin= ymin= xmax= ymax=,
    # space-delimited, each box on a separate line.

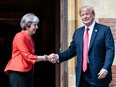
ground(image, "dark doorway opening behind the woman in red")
xmin=0 ymin=0 xmax=59 ymax=87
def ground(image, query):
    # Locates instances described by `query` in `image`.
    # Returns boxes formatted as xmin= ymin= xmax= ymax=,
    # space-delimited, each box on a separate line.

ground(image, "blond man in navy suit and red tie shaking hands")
xmin=50 ymin=6 xmax=115 ymax=87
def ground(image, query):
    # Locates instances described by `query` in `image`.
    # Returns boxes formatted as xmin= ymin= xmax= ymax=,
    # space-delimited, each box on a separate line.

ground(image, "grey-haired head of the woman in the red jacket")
xmin=20 ymin=13 xmax=39 ymax=36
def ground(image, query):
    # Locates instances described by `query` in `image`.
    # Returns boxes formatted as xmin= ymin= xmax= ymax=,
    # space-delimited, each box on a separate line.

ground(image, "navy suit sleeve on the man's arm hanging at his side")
xmin=103 ymin=28 xmax=115 ymax=70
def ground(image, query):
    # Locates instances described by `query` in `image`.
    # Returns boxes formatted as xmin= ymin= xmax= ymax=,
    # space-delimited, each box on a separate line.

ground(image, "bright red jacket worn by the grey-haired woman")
xmin=4 ymin=30 xmax=37 ymax=74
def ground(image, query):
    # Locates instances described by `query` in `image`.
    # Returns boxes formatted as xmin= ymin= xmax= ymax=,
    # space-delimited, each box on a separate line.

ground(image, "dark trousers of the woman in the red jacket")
xmin=9 ymin=71 xmax=34 ymax=87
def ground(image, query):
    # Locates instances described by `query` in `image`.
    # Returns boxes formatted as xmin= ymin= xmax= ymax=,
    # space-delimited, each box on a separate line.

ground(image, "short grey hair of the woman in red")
xmin=20 ymin=13 xmax=39 ymax=29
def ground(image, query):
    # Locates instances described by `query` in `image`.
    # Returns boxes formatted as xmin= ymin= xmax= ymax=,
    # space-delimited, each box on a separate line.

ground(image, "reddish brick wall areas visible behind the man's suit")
xmin=99 ymin=18 xmax=116 ymax=87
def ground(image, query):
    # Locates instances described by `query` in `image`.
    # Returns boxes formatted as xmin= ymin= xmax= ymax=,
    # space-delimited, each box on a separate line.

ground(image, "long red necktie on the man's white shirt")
xmin=83 ymin=28 xmax=89 ymax=72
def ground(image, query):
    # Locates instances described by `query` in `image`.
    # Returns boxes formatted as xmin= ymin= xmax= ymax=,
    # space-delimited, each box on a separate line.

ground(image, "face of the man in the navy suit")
xmin=80 ymin=8 xmax=94 ymax=27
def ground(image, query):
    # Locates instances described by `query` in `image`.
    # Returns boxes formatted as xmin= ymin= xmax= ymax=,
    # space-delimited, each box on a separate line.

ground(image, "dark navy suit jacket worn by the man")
xmin=58 ymin=23 xmax=115 ymax=87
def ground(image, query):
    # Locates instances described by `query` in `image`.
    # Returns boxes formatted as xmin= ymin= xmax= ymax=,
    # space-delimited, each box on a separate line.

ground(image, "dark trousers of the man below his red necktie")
xmin=79 ymin=64 xmax=109 ymax=87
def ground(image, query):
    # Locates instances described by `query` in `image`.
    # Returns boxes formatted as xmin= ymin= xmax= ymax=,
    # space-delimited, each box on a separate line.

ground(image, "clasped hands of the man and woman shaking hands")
xmin=44 ymin=53 xmax=59 ymax=63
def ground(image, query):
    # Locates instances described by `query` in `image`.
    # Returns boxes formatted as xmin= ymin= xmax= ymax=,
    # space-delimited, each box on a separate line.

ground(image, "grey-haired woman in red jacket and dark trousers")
xmin=4 ymin=13 xmax=53 ymax=87
